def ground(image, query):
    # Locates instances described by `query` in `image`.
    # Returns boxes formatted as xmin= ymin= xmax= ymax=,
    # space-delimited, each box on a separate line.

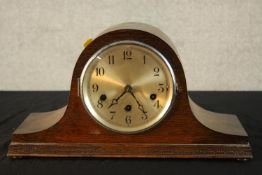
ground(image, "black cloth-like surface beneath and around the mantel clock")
xmin=0 ymin=91 xmax=262 ymax=175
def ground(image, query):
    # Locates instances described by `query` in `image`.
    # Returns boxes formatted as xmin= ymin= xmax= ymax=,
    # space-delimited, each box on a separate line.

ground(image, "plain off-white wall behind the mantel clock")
xmin=0 ymin=0 xmax=262 ymax=90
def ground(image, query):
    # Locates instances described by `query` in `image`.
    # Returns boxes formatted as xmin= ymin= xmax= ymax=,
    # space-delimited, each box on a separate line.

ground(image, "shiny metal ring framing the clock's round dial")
xmin=80 ymin=40 xmax=176 ymax=134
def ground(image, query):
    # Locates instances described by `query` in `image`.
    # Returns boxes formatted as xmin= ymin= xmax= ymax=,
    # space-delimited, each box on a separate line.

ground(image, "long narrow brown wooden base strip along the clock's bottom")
xmin=8 ymin=143 xmax=252 ymax=159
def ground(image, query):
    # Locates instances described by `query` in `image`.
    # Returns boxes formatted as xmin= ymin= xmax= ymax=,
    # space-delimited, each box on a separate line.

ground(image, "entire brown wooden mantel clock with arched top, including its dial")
xmin=8 ymin=23 xmax=252 ymax=159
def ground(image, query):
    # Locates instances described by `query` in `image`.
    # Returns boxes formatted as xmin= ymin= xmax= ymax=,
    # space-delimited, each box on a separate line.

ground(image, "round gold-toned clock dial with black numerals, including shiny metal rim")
xmin=80 ymin=41 xmax=176 ymax=133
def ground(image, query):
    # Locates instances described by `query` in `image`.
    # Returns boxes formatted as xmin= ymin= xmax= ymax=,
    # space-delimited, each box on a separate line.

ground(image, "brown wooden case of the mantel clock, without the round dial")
xmin=8 ymin=23 xmax=252 ymax=159
